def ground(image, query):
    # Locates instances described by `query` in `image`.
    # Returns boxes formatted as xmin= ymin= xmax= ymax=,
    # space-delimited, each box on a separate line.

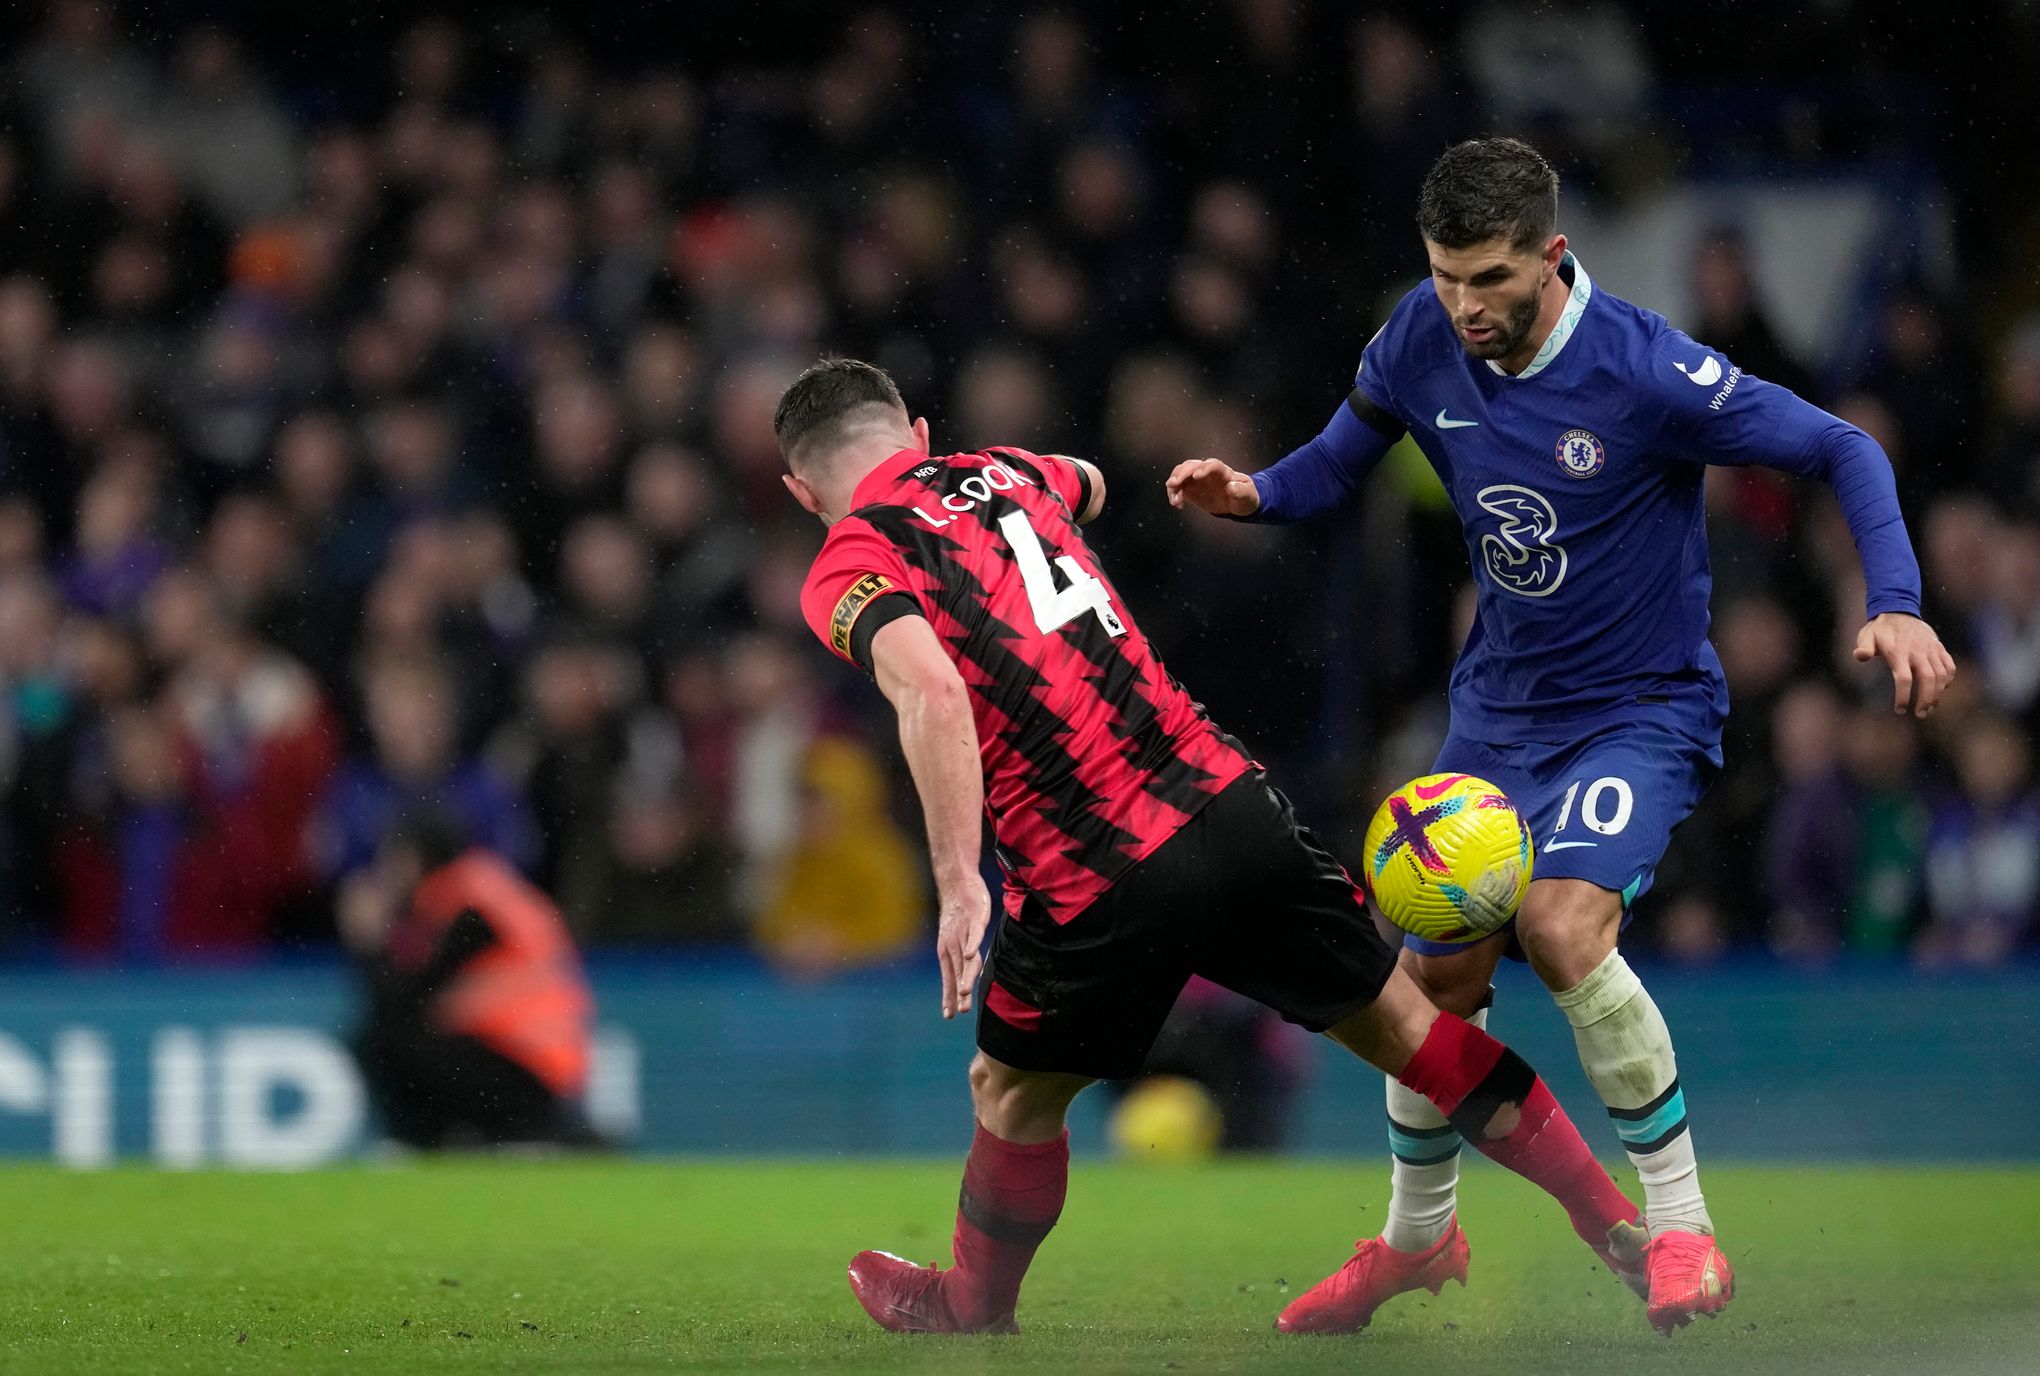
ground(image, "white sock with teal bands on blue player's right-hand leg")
xmin=1552 ymin=950 xmax=1714 ymax=1237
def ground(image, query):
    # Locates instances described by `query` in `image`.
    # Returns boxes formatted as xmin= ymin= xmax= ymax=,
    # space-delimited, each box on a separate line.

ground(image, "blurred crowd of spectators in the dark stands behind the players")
xmin=0 ymin=0 xmax=2040 ymax=974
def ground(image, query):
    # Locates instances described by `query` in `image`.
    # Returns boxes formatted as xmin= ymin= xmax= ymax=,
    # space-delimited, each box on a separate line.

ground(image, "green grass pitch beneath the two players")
xmin=0 ymin=1158 xmax=2040 ymax=1376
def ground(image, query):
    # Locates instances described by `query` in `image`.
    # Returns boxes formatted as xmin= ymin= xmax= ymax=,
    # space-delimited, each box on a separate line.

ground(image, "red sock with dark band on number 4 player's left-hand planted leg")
xmin=942 ymin=1125 xmax=1069 ymax=1327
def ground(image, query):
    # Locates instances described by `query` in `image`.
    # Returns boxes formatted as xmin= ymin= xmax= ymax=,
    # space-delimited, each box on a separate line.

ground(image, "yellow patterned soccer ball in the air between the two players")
xmin=1365 ymin=775 xmax=1530 ymax=942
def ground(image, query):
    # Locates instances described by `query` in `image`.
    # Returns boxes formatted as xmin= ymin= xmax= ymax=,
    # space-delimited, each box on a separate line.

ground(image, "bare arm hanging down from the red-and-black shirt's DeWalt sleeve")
xmin=871 ymin=616 xmax=991 ymax=1017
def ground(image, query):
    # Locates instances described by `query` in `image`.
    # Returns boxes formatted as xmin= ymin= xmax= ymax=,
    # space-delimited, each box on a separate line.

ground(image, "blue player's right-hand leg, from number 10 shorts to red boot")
xmin=1516 ymin=728 xmax=1734 ymax=1327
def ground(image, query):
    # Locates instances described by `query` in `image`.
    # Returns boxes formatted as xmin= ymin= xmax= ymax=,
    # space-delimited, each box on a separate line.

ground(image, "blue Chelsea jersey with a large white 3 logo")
xmin=1321 ymin=255 xmax=1920 ymax=742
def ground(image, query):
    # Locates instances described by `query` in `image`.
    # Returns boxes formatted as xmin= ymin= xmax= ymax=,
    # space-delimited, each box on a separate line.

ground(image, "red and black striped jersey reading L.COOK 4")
xmin=802 ymin=448 xmax=1253 ymax=921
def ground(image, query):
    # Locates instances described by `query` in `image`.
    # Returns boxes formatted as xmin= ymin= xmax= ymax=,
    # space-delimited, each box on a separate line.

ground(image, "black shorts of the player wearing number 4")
xmin=977 ymin=773 xmax=1395 ymax=1078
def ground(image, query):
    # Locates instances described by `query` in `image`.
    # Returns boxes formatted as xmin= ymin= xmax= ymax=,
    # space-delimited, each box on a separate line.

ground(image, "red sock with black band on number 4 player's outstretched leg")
xmin=1399 ymin=1013 xmax=1638 ymax=1246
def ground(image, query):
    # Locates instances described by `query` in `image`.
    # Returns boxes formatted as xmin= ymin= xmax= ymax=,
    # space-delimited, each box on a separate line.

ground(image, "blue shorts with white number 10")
xmin=1404 ymin=722 xmax=1722 ymax=956
